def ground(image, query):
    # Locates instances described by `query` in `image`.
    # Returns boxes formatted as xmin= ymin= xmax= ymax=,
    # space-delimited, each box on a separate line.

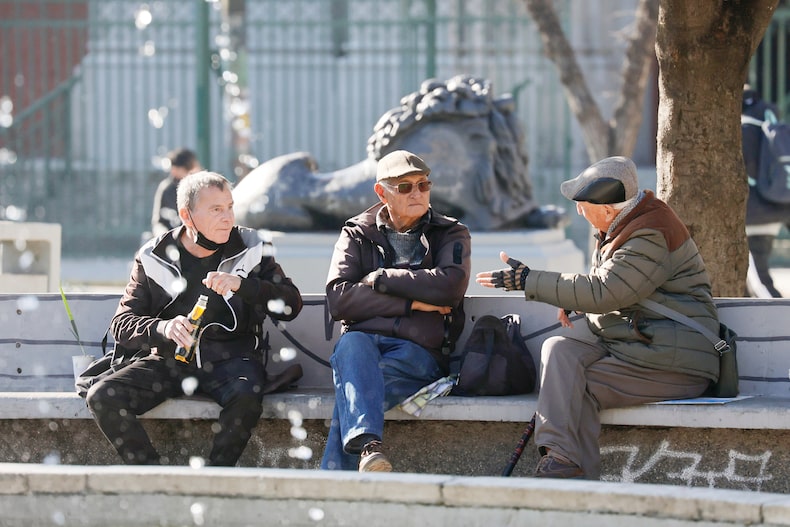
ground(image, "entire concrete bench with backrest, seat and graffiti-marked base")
xmin=0 ymin=293 xmax=790 ymax=492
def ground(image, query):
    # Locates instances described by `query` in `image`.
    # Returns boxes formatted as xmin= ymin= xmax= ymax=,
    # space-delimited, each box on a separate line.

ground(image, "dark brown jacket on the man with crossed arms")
xmin=326 ymin=203 xmax=471 ymax=371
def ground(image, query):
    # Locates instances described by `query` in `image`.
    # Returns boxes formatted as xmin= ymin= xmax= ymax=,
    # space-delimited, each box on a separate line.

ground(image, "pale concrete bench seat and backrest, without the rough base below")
xmin=0 ymin=293 xmax=790 ymax=429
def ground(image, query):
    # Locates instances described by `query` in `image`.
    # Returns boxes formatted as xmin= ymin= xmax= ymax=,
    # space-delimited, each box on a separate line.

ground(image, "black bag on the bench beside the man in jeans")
xmin=452 ymin=314 xmax=537 ymax=396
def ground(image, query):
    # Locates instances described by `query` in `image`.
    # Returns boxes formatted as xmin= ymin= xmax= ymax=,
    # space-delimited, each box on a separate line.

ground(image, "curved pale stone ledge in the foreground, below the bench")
xmin=0 ymin=464 xmax=790 ymax=527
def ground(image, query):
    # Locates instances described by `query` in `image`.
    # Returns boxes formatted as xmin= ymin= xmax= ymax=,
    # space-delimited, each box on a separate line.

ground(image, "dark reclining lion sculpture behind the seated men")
xmin=233 ymin=76 xmax=566 ymax=232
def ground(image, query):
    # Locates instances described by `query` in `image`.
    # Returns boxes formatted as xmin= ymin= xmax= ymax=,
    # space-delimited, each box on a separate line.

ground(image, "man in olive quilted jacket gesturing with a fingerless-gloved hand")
xmin=477 ymin=157 xmax=719 ymax=479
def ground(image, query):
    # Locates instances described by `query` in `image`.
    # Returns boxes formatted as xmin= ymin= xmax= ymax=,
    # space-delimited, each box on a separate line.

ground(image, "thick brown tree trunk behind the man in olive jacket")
xmin=656 ymin=0 xmax=778 ymax=296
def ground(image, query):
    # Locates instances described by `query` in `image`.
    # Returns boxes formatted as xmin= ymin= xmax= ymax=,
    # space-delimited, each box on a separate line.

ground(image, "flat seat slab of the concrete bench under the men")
xmin=0 ymin=389 xmax=790 ymax=430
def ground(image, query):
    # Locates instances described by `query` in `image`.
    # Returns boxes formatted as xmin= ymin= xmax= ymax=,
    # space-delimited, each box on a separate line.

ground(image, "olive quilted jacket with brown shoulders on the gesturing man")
xmin=525 ymin=190 xmax=719 ymax=380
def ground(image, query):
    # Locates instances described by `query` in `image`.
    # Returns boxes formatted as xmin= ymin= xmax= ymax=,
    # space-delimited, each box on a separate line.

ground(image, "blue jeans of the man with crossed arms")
xmin=321 ymin=331 xmax=442 ymax=470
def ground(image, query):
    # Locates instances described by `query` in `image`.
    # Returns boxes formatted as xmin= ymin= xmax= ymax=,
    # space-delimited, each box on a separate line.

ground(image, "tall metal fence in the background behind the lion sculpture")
xmin=0 ymin=0 xmax=787 ymax=256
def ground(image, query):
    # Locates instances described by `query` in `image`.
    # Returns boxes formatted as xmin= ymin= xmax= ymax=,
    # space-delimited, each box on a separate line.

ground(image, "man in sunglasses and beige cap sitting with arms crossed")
xmin=321 ymin=150 xmax=471 ymax=472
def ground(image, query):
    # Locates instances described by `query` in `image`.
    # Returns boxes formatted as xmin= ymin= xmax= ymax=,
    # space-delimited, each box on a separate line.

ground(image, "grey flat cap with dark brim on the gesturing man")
xmin=560 ymin=156 xmax=639 ymax=205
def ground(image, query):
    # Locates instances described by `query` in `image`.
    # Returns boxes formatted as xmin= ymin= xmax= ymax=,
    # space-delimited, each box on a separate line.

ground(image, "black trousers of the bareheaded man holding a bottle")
xmin=86 ymin=355 xmax=265 ymax=466
